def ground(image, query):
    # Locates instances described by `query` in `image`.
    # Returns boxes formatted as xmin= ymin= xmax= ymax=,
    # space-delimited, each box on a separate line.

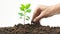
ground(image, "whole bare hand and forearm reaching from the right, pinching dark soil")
xmin=31 ymin=4 xmax=60 ymax=24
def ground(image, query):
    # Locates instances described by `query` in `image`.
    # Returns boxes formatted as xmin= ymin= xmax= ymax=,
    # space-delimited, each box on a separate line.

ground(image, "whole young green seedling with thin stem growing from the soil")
xmin=18 ymin=4 xmax=31 ymax=24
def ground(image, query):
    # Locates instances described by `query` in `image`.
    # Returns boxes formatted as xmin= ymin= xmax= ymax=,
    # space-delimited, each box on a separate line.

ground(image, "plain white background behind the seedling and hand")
xmin=0 ymin=0 xmax=60 ymax=27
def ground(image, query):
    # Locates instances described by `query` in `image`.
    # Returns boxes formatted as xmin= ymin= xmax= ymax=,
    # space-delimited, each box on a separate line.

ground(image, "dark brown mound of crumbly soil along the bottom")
xmin=0 ymin=24 xmax=60 ymax=34
